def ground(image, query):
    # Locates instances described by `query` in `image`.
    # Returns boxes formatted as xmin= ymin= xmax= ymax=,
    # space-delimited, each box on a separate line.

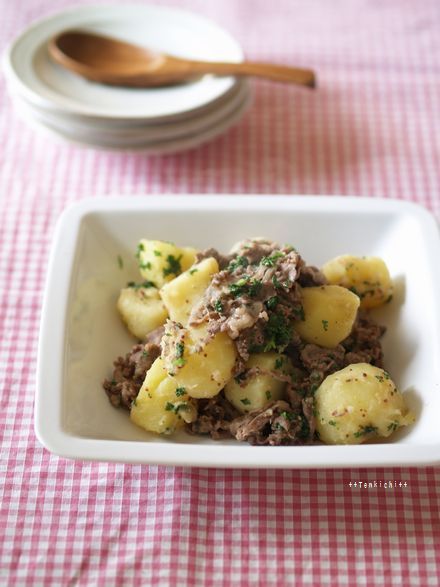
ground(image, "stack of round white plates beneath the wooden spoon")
xmin=3 ymin=5 xmax=250 ymax=153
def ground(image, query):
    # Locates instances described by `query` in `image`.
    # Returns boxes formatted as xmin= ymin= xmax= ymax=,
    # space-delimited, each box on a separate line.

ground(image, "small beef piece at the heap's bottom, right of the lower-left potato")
xmin=187 ymin=392 xmax=240 ymax=440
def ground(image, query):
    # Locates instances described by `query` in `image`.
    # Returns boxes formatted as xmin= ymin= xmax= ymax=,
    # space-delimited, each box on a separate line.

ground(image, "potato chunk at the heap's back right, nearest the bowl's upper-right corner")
xmin=322 ymin=255 xmax=393 ymax=308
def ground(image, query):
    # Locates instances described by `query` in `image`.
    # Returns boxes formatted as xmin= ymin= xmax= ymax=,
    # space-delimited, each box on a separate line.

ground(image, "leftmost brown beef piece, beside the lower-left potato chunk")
xmin=103 ymin=342 xmax=160 ymax=410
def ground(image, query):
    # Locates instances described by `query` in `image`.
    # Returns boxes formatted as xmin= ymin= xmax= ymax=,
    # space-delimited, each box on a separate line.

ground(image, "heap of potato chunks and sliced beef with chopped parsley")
xmin=103 ymin=238 xmax=414 ymax=445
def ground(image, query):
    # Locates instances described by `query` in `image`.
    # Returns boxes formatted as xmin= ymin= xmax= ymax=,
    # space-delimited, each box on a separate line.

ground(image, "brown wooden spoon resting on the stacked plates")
xmin=49 ymin=30 xmax=315 ymax=88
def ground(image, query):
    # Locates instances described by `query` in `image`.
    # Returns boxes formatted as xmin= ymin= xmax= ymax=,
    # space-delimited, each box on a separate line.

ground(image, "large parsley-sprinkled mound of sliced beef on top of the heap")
xmin=190 ymin=239 xmax=304 ymax=361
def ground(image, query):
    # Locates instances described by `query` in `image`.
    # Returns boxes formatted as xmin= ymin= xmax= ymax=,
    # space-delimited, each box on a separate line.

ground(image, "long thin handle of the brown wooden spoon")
xmin=183 ymin=61 xmax=316 ymax=88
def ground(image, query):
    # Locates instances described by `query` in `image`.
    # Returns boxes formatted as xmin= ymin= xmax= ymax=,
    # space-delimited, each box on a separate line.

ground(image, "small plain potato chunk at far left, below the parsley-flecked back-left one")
xmin=116 ymin=286 xmax=168 ymax=340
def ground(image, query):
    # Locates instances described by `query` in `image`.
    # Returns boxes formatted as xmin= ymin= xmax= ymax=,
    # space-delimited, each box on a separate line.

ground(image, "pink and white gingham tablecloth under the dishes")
xmin=0 ymin=0 xmax=440 ymax=587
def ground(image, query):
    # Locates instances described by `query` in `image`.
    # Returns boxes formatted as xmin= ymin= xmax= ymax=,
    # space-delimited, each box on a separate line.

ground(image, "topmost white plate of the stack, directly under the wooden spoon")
xmin=4 ymin=5 xmax=243 ymax=120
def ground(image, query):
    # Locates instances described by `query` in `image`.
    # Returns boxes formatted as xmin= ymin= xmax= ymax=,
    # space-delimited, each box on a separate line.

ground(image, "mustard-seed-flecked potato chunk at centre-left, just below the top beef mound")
xmin=162 ymin=322 xmax=237 ymax=398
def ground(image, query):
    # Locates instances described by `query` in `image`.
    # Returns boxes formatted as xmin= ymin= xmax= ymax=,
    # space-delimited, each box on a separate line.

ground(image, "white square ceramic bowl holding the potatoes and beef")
xmin=35 ymin=195 xmax=440 ymax=468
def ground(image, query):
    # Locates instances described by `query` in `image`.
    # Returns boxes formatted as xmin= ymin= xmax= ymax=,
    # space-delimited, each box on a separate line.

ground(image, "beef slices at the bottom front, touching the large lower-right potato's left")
xmin=230 ymin=400 xmax=313 ymax=446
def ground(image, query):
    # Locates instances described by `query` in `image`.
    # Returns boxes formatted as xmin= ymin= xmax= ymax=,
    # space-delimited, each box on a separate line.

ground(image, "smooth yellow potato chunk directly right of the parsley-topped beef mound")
xmin=293 ymin=285 xmax=360 ymax=348
